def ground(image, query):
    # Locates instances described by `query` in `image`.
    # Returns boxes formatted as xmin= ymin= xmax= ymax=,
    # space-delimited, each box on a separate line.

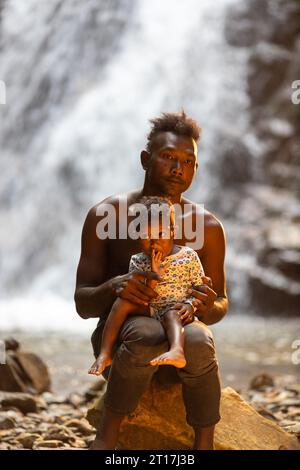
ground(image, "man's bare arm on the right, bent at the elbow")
xmin=191 ymin=214 xmax=229 ymax=325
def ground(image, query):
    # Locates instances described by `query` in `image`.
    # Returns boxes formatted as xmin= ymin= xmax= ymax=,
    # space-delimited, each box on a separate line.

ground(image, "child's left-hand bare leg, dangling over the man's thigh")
xmin=89 ymin=298 xmax=145 ymax=375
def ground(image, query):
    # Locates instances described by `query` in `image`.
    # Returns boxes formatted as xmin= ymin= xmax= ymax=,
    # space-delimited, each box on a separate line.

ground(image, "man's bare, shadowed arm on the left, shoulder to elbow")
xmin=74 ymin=206 xmax=116 ymax=318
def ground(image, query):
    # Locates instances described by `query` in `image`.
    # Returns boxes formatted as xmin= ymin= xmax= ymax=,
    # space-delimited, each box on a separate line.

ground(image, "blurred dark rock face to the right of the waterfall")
xmin=214 ymin=0 xmax=300 ymax=315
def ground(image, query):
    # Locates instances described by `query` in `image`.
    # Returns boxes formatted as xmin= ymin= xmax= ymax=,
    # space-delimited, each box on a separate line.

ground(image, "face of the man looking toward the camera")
xmin=147 ymin=132 xmax=198 ymax=196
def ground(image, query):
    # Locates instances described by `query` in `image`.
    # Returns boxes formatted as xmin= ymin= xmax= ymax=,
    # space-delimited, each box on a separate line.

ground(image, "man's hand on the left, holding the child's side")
xmin=113 ymin=271 xmax=161 ymax=305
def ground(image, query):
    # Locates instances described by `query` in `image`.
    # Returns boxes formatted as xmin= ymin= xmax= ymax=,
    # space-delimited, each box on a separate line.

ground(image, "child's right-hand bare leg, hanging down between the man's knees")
xmin=150 ymin=310 xmax=186 ymax=368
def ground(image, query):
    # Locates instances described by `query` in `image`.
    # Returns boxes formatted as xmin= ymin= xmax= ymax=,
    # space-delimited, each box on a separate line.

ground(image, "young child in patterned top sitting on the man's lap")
xmin=89 ymin=196 xmax=204 ymax=375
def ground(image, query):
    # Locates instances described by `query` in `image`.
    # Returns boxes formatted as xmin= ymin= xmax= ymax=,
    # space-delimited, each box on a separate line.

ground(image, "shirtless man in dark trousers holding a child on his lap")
xmin=75 ymin=112 xmax=228 ymax=450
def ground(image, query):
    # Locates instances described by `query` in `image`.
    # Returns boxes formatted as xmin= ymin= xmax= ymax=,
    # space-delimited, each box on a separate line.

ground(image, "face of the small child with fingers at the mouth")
xmin=140 ymin=221 xmax=174 ymax=258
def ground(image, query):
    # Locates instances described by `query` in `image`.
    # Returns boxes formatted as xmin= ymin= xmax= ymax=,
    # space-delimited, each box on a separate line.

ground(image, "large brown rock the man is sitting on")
xmin=87 ymin=382 xmax=300 ymax=450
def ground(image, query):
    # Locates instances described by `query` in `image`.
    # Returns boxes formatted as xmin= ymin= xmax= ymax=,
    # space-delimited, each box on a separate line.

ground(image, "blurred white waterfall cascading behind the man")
xmin=0 ymin=0 xmax=251 ymax=330
